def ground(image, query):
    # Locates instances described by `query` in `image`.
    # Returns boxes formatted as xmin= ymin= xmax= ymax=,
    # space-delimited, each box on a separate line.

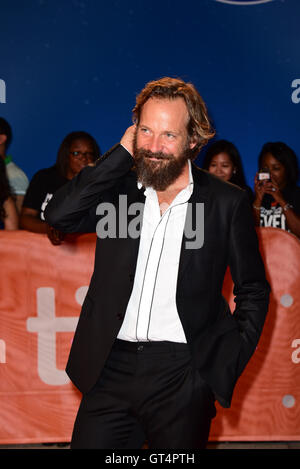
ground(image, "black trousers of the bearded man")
xmin=71 ymin=340 xmax=216 ymax=449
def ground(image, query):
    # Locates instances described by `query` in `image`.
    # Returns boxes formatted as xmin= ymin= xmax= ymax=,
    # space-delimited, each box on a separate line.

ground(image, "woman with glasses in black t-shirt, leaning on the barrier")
xmin=20 ymin=131 xmax=101 ymax=244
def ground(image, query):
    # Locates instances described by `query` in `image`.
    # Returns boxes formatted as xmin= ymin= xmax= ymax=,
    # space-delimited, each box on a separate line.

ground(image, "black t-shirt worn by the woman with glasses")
xmin=23 ymin=166 xmax=68 ymax=221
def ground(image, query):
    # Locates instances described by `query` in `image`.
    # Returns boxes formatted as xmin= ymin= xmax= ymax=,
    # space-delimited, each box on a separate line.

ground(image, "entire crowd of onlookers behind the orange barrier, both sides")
xmin=0 ymin=118 xmax=300 ymax=239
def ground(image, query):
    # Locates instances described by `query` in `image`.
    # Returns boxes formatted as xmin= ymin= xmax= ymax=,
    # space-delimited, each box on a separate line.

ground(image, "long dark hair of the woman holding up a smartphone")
xmin=258 ymin=142 xmax=299 ymax=186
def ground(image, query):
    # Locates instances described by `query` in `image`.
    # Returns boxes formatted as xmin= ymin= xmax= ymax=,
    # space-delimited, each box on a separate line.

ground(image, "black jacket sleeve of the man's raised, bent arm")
xmin=45 ymin=144 xmax=133 ymax=233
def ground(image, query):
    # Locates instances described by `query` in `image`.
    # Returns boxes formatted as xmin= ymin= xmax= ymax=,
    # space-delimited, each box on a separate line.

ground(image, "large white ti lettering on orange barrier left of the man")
xmin=27 ymin=286 xmax=88 ymax=386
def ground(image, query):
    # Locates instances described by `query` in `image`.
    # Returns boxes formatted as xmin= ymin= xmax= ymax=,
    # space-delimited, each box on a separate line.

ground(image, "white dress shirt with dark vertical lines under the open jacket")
xmin=118 ymin=161 xmax=193 ymax=343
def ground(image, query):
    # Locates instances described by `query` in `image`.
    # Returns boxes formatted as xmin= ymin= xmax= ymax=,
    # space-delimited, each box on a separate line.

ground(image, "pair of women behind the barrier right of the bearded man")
xmin=203 ymin=140 xmax=300 ymax=238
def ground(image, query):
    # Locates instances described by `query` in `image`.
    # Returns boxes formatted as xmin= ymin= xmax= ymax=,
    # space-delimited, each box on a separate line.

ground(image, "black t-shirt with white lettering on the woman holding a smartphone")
xmin=260 ymin=186 xmax=300 ymax=231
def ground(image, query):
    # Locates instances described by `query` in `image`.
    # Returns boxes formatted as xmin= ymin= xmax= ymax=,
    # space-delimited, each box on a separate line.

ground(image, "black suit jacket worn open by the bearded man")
xmin=45 ymin=145 xmax=269 ymax=407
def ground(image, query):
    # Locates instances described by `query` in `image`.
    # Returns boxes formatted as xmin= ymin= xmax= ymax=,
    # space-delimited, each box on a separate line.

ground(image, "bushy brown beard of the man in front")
xmin=133 ymin=138 xmax=191 ymax=191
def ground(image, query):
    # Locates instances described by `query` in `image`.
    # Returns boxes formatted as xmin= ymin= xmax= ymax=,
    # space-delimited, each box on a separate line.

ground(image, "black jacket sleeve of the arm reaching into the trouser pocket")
xmin=229 ymin=190 xmax=270 ymax=375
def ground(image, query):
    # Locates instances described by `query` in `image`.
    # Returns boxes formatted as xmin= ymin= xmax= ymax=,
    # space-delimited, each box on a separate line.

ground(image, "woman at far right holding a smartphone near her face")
xmin=253 ymin=142 xmax=300 ymax=238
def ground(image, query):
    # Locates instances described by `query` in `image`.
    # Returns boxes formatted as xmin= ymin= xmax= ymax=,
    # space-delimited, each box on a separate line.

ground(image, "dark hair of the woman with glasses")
xmin=55 ymin=130 xmax=101 ymax=178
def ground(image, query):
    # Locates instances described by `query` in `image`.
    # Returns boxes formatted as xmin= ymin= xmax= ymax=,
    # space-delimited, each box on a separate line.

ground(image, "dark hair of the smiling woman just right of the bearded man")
xmin=202 ymin=140 xmax=247 ymax=189
